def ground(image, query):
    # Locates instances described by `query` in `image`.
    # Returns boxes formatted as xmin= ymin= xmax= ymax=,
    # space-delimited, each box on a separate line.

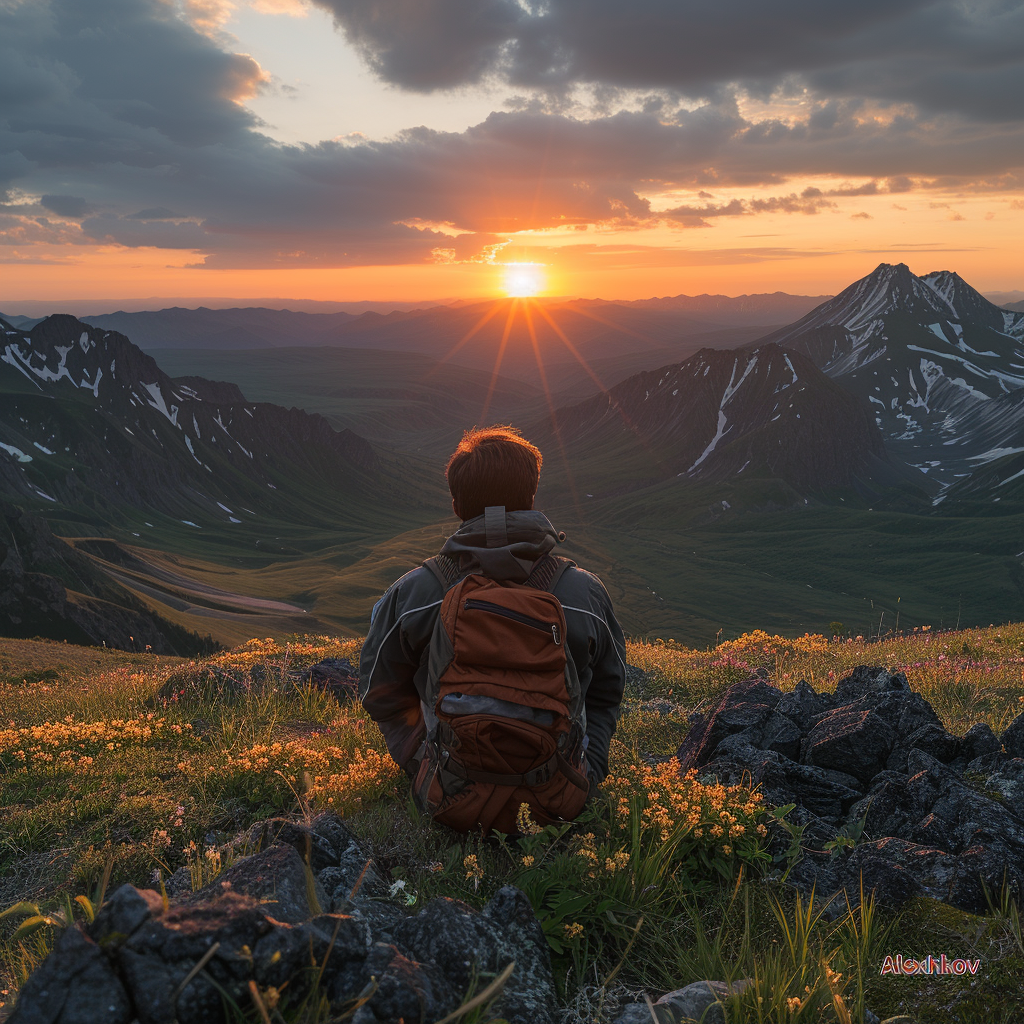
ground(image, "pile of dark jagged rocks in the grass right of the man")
xmin=678 ymin=667 xmax=1024 ymax=912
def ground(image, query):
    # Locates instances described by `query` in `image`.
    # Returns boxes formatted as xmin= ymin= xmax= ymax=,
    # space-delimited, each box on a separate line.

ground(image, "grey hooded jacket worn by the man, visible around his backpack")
xmin=359 ymin=511 xmax=626 ymax=780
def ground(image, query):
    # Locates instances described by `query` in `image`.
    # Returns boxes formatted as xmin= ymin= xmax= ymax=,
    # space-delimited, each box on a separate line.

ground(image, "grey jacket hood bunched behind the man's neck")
xmin=440 ymin=506 xmax=565 ymax=583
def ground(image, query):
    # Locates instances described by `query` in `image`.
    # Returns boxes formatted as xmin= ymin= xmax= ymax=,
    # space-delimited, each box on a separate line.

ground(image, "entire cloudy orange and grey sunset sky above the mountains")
xmin=0 ymin=0 xmax=1024 ymax=303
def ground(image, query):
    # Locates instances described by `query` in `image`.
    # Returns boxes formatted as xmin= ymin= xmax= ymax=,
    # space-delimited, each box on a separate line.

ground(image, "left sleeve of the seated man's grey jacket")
xmin=359 ymin=569 xmax=440 ymax=771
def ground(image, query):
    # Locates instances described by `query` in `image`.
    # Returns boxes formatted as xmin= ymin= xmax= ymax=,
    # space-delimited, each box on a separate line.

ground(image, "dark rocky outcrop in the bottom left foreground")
xmin=9 ymin=814 xmax=556 ymax=1024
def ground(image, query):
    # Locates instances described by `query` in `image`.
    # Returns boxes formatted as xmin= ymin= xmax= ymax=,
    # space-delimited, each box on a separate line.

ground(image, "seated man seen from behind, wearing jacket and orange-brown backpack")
xmin=359 ymin=427 xmax=626 ymax=831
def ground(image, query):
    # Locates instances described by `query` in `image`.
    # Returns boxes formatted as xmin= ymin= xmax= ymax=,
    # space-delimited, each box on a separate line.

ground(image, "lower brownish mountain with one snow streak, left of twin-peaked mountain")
xmin=555 ymin=343 xmax=916 ymax=495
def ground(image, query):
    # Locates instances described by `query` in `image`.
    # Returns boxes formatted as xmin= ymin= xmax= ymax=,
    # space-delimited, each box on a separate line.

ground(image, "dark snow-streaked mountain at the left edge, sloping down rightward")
xmin=0 ymin=315 xmax=376 ymax=525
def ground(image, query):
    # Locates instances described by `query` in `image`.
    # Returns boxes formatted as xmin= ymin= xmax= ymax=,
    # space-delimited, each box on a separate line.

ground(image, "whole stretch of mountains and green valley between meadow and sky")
xmin=0 ymin=264 xmax=1024 ymax=649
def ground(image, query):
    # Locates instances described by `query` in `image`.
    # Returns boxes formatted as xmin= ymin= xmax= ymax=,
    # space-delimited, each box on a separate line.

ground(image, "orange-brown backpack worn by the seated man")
xmin=413 ymin=555 xmax=590 ymax=835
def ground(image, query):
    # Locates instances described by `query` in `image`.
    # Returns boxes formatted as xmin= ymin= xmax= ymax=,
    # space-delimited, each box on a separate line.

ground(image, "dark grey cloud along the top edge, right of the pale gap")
xmin=313 ymin=0 xmax=1024 ymax=120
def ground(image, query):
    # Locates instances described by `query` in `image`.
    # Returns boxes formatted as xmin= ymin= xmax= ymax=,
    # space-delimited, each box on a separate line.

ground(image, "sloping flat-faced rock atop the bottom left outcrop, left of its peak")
xmin=186 ymin=846 xmax=330 ymax=925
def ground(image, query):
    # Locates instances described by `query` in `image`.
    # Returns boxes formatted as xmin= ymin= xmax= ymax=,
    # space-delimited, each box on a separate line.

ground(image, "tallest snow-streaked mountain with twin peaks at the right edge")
xmin=759 ymin=263 xmax=1024 ymax=502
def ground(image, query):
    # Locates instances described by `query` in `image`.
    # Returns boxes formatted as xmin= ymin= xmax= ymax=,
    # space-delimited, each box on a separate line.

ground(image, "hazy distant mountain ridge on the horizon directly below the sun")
xmin=49 ymin=296 xmax=782 ymax=382
